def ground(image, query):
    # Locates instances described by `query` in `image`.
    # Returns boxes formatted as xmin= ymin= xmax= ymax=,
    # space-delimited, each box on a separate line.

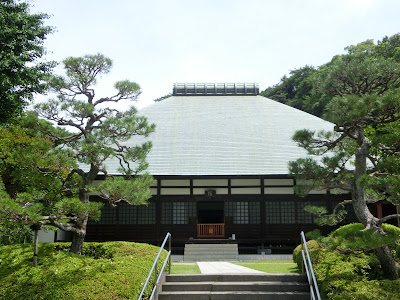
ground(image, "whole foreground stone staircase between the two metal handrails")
xmin=158 ymin=273 xmax=310 ymax=300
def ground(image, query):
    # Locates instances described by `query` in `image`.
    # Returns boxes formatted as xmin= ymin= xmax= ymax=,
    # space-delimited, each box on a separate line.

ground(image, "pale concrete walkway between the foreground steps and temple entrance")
xmin=197 ymin=261 xmax=265 ymax=274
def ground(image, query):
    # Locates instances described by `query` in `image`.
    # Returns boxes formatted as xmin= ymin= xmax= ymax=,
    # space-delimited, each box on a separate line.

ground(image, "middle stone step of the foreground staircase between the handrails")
xmin=162 ymin=281 xmax=310 ymax=292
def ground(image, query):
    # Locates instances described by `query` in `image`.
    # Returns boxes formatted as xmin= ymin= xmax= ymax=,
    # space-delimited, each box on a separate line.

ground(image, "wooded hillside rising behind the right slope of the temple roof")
xmin=261 ymin=34 xmax=400 ymax=118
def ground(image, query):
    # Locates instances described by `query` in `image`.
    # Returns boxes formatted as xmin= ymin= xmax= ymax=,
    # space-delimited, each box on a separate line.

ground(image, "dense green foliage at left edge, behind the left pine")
xmin=0 ymin=113 xmax=74 ymax=248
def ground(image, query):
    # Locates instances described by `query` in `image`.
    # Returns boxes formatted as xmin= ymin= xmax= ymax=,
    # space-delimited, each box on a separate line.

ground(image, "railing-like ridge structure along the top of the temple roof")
xmin=173 ymin=83 xmax=259 ymax=96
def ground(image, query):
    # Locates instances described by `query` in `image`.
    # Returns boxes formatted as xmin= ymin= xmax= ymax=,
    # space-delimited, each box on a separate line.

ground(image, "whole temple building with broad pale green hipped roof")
xmin=79 ymin=83 xmax=355 ymax=252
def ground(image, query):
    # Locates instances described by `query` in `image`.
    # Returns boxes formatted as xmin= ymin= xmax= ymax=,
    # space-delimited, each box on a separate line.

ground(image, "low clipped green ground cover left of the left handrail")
xmin=0 ymin=242 xmax=165 ymax=300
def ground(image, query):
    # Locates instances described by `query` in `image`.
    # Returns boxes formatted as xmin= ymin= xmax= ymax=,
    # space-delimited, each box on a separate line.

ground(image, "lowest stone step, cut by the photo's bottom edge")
xmin=158 ymin=291 xmax=310 ymax=300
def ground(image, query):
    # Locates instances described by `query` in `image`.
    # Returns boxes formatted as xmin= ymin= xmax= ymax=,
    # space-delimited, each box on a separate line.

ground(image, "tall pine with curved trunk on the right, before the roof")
xmin=290 ymin=43 xmax=400 ymax=279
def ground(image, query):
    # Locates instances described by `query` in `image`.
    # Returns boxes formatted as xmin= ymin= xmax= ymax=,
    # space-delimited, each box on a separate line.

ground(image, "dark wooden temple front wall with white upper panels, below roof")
xmin=86 ymin=176 xmax=355 ymax=251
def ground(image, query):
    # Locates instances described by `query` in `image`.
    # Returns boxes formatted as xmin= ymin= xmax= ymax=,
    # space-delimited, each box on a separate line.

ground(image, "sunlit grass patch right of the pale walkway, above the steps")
xmin=234 ymin=260 xmax=301 ymax=273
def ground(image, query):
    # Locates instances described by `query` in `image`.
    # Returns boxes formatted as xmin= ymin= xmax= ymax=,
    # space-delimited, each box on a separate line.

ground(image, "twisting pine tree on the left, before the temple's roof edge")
xmin=35 ymin=54 xmax=155 ymax=253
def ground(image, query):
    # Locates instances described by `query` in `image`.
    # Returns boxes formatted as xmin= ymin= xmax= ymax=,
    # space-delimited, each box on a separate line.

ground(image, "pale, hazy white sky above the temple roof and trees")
xmin=30 ymin=0 xmax=400 ymax=108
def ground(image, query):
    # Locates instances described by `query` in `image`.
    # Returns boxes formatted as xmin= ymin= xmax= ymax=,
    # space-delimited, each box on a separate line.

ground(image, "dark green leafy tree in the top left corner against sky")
xmin=0 ymin=0 xmax=54 ymax=123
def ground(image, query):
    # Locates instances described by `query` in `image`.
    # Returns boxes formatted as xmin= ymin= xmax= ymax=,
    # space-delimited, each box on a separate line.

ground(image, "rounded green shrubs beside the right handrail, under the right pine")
xmin=293 ymin=224 xmax=400 ymax=300
